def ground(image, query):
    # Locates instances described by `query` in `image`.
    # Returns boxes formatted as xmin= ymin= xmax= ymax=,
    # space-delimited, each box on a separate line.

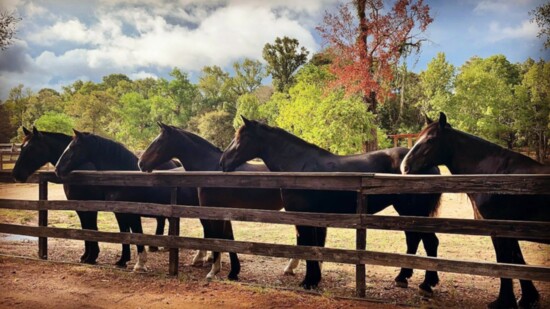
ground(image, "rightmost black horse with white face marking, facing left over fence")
xmin=401 ymin=113 xmax=550 ymax=308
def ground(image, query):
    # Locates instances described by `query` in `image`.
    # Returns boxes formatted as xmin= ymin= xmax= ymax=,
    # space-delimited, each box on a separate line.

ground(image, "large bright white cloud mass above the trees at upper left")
xmin=0 ymin=0 xmax=328 ymax=97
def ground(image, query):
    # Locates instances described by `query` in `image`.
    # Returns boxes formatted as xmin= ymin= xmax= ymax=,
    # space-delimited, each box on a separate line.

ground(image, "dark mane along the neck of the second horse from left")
xmin=83 ymin=133 xmax=138 ymax=169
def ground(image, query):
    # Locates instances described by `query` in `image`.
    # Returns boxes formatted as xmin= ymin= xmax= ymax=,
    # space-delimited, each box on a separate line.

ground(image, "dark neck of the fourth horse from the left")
xmin=260 ymin=128 xmax=334 ymax=172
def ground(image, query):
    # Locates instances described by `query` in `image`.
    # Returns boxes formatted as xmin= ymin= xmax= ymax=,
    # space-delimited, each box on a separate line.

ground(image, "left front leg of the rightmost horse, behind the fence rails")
xmin=487 ymin=237 xmax=517 ymax=308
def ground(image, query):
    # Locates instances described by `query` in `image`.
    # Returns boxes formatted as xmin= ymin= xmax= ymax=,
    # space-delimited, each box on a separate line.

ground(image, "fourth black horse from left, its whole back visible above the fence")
xmin=220 ymin=117 xmax=441 ymax=295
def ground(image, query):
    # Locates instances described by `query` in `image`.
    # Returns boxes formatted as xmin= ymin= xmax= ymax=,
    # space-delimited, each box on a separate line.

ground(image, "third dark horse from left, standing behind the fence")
xmin=139 ymin=122 xmax=299 ymax=280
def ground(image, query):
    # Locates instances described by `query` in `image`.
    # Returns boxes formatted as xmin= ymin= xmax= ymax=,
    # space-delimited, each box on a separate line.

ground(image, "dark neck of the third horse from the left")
xmin=174 ymin=132 xmax=222 ymax=171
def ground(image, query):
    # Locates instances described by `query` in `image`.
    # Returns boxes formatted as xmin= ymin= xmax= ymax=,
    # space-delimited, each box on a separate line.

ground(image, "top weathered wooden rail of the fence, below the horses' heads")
xmin=34 ymin=171 xmax=550 ymax=194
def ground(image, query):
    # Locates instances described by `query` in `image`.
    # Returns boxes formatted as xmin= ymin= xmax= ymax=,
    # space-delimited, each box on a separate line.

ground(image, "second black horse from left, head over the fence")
xmin=55 ymin=130 xmax=198 ymax=270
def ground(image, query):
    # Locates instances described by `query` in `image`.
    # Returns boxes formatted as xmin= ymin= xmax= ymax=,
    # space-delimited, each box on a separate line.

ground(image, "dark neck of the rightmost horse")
xmin=446 ymin=130 xmax=541 ymax=174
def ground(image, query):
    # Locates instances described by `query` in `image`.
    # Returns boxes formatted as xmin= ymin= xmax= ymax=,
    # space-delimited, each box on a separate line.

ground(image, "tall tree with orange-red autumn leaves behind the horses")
xmin=317 ymin=0 xmax=433 ymax=151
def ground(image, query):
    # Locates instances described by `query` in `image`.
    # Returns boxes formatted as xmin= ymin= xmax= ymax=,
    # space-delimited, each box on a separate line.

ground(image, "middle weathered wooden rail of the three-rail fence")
xmin=0 ymin=199 xmax=550 ymax=240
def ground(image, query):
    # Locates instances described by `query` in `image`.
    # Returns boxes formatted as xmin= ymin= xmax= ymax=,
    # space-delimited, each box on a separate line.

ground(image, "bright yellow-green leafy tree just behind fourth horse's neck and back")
xmin=275 ymin=65 xmax=373 ymax=154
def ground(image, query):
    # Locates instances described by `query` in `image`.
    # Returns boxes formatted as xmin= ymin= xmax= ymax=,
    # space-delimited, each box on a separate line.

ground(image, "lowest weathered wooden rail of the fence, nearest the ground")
xmin=0 ymin=224 xmax=550 ymax=281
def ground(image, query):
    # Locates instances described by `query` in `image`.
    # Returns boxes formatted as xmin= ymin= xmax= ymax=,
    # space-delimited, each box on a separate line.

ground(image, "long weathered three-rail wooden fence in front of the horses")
xmin=0 ymin=172 xmax=550 ymax=297
